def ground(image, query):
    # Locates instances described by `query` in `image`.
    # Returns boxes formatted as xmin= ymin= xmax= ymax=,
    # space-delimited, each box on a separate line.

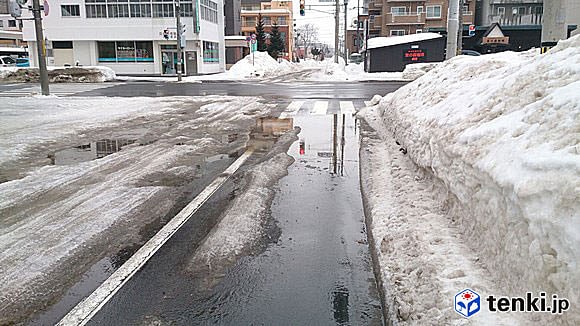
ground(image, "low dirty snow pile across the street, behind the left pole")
xmin=0 ymin=66 xmax=116 ymax=83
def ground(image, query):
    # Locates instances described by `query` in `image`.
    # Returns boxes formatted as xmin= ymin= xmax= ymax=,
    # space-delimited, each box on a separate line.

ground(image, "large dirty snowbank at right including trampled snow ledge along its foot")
xmin=362 ymin=36 xmax=580 ymax=324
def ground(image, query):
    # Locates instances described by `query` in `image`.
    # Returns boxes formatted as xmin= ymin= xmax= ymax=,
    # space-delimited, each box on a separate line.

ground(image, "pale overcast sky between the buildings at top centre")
xmin=294 ymin=0 xmax=362 ymax=47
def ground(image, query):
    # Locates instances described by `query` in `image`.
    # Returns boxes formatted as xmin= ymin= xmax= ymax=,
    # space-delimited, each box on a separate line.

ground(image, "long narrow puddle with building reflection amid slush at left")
xmin=49 ymin=139 xmax=137 ymax=165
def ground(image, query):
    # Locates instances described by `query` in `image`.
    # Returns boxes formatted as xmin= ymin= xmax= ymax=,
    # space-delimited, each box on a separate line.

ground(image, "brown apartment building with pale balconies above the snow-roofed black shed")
xmin=368 ymin=0 xmax=475 ymax=37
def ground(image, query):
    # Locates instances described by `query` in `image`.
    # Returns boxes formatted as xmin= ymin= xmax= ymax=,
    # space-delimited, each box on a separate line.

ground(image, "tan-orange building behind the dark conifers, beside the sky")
xmin=241 ymin=0 xmax=294 ymax=61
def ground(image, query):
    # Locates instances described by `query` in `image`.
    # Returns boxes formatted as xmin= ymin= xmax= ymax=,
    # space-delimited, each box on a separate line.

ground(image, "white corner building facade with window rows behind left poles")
xmin=23 ymin=0 xmax=225 ymax=75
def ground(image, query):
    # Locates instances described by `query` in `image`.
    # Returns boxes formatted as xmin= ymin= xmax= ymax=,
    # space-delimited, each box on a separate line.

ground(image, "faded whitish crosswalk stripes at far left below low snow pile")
xmin=0 ymin=83 xmax=120 ymax=97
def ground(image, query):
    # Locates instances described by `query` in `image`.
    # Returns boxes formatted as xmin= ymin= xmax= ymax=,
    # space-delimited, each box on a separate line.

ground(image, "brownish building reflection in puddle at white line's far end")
xmin=250 ymin=117 xmax=294 ymax=151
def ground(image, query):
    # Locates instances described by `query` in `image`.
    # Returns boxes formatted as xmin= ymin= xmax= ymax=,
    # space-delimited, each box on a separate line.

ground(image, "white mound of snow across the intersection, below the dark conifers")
xmin=227 ymin=51 xmax=291 ymax=78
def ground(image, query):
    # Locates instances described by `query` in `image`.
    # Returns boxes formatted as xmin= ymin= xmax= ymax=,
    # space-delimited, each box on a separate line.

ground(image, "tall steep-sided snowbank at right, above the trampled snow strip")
xmin=364 ymin=36 xmax=580 ymax=324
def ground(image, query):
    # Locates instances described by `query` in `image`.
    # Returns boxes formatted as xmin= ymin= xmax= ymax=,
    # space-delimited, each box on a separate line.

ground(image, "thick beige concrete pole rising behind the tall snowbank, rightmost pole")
xmin=542 ymin=0 xmax=568 ymax=53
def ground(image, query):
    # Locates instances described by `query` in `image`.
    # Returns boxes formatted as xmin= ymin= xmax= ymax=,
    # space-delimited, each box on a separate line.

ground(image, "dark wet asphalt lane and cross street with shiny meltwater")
xmin=18 ymin=82 xmax=404 ymax=325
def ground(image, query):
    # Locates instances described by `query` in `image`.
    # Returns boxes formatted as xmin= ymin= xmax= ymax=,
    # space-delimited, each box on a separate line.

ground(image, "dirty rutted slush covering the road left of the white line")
xmin=0 ymin=97 xmax=269 ymax=324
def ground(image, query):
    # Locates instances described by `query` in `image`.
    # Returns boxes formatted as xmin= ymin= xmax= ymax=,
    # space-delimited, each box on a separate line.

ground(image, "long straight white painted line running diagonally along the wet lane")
xmin=57 ymin=149 xmax=253 ymax=326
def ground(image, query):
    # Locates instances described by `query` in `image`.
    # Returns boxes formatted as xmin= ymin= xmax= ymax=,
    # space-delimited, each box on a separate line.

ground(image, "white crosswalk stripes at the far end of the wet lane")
xmin=280 ymin=100 xmax=365 ymax=119
